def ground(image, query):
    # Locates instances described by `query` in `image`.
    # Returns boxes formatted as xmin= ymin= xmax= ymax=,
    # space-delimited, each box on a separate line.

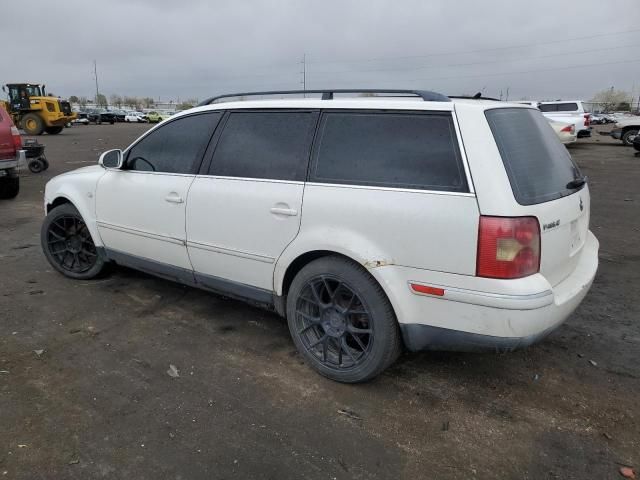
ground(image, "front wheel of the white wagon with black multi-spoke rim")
xmin=40 ymin=203 xmax=106 ymax=280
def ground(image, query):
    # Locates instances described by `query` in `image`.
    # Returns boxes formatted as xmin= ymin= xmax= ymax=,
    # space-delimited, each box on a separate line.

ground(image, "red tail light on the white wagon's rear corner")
xmin=476 ymin=216 xmax=540 ymax=279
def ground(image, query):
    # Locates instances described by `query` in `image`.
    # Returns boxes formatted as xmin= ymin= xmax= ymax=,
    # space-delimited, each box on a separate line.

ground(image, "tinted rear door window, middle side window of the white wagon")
xmin=209 ymin=112 xmax=317 ymax=180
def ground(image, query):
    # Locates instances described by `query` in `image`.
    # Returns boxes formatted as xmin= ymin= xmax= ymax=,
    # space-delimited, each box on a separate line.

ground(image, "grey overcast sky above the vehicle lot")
xmin=0 ymin=0 xmax=640 ymax=100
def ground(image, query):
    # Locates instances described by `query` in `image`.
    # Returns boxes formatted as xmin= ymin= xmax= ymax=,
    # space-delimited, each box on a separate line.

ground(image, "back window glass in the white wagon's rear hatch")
xmin=485 ymin=108 xmax=581 ymax=205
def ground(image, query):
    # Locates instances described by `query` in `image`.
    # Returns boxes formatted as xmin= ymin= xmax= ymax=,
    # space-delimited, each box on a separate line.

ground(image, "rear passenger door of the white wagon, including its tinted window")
xmin=187 ymin=110 xmax=318 ymax=292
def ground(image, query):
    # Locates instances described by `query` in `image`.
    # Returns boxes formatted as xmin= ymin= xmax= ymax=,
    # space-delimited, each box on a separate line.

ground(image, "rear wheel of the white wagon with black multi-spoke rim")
xmin=287 ymin=256 xmax=402 ymax=383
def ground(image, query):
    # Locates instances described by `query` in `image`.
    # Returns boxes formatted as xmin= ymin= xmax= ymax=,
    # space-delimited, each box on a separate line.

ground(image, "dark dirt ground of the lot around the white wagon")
xmin=0 ymin=124 xmax=640 ymax=480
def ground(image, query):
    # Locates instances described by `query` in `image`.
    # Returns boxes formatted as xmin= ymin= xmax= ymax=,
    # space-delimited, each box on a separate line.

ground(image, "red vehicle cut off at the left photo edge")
xmin=0 ymin=108 xmax=26 ymax=199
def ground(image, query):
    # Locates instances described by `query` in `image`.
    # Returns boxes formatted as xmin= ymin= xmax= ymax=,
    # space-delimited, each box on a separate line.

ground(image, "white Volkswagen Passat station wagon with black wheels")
xmin=42 ymin=91 xmax=598 ymax=382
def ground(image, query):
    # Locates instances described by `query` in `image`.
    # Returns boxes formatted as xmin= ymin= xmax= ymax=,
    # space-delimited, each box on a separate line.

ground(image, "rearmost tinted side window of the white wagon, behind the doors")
xmin=311 ymin=112 xmax=468 ymax=192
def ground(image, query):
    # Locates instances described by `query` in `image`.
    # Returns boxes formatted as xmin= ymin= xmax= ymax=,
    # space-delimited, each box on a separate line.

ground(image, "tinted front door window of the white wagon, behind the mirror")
xmin=126 ymin=112 xmax=222 ymax=173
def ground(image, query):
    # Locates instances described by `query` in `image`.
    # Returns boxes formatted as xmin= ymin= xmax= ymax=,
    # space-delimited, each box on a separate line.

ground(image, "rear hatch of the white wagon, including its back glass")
xmin=486 ymin=108 xmax=590 ymax=286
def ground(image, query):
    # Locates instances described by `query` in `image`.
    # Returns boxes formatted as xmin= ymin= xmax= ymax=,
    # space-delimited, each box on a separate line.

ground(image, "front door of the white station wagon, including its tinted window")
xmin=96 ymin=112 xmax=221 ymax=280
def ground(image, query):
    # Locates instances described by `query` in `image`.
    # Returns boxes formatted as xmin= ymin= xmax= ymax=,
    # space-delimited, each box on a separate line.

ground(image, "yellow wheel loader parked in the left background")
xmin=0 ymin=83 xmax=77 ymax=135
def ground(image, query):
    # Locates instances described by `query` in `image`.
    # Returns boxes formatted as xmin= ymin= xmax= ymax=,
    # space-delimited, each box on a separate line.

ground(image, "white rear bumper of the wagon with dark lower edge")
xmin=371 ymin=232 xmax=599 ymax=351
